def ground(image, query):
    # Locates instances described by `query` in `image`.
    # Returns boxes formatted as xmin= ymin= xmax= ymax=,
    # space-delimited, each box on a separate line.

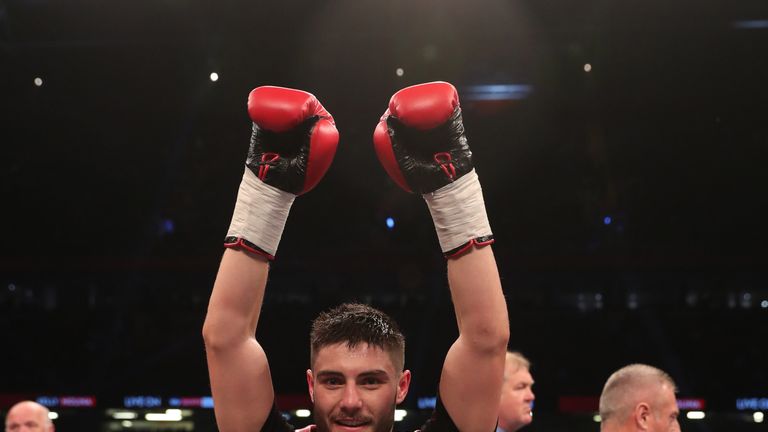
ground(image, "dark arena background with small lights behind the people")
xmin=0 ymin=0 xmax=768 ymax=432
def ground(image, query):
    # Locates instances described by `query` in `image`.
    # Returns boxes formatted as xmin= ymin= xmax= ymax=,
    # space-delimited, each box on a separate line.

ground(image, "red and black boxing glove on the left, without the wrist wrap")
xmin=245 ymin=86 xmax=339 ymax=195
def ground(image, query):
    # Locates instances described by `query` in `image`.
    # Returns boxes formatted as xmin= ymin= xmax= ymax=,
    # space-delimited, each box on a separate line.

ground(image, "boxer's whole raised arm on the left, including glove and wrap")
xmin=203 ymin=87 xmax=338 ymax=432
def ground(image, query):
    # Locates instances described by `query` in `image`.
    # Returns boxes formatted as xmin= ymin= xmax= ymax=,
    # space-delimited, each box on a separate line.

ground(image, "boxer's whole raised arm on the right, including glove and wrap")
xmin=374 ymin=82 xmax=509 ymax=432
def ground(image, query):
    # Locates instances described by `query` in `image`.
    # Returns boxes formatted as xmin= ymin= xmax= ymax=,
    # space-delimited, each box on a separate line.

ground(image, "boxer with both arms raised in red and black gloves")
xmin=203 ymin=83 xmax=509 ymax=432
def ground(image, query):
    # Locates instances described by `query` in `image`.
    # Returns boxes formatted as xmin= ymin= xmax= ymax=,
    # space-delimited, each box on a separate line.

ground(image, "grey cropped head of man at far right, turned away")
xmin=600 ymin=364 xmax=680 ymax=432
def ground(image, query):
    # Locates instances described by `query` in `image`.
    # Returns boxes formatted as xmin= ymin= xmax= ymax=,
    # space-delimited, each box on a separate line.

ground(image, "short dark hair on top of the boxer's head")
xmin=310 ymin=303 xmax=405 ymax=370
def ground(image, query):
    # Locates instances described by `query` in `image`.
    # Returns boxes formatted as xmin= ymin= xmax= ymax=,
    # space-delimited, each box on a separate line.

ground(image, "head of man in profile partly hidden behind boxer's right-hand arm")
xmin=499 ymin=351 xmax=535 ymax=432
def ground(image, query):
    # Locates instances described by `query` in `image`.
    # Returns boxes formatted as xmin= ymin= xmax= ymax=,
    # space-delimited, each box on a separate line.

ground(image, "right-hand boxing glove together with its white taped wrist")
xmin=373 ymin=82 xmax=493 ymax=257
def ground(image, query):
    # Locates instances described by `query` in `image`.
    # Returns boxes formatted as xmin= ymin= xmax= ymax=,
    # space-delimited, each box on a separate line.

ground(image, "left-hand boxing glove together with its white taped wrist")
xmin=224 ymin=86 xmax=339 ymax=259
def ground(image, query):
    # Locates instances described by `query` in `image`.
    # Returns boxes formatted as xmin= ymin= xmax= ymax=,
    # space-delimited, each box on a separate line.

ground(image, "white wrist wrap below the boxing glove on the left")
xmin=227 ymin=167 xmax=296 ymax=258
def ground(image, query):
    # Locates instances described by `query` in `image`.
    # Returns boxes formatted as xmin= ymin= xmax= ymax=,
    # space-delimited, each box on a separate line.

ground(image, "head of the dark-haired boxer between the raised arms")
xmin=307 ymin=303 xmax=411 ymax=432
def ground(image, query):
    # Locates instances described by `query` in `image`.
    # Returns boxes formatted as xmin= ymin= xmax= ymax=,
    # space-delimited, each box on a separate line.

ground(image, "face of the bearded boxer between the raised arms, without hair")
xmin=307 ymin=343 xmax=411 ymax=432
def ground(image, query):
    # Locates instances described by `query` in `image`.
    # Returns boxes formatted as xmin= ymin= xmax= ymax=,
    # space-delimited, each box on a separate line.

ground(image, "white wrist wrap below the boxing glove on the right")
xmin=422 ymin=169 xmax=493 ymax=255
